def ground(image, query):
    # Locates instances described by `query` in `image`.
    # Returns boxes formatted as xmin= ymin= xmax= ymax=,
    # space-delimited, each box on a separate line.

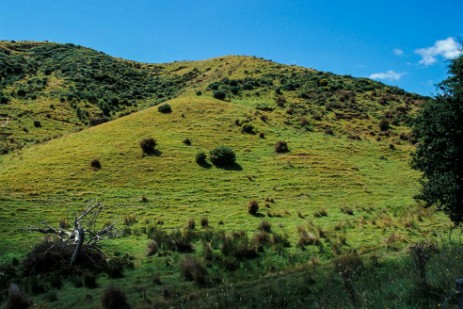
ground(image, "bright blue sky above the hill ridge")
xmin=0 ymin=0 xmax=463 ymax=95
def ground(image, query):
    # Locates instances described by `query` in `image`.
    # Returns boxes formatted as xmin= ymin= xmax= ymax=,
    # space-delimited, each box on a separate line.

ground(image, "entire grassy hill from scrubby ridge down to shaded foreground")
xmin=0 ymin=42 xmax=461 ymax=308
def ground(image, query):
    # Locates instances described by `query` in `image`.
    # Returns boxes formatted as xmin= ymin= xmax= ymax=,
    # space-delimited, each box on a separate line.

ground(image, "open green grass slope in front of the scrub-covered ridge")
xmin=0 ymin=98 xmax=454 ymax=308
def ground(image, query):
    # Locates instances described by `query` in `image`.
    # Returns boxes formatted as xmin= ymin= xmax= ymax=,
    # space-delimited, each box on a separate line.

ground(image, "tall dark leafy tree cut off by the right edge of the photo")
xmin=412 ymin=55 xmax=463 ymax=221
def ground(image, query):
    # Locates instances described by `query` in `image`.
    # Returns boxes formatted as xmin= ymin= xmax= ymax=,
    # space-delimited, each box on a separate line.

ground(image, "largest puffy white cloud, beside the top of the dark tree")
xmin=415 ymin=37 xmax=461 ymax=65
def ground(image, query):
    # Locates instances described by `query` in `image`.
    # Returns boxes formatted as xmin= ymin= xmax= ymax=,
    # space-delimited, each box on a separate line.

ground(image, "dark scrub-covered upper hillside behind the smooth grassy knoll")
xmin=0 ymin=41 xmax=423 ymax=153
